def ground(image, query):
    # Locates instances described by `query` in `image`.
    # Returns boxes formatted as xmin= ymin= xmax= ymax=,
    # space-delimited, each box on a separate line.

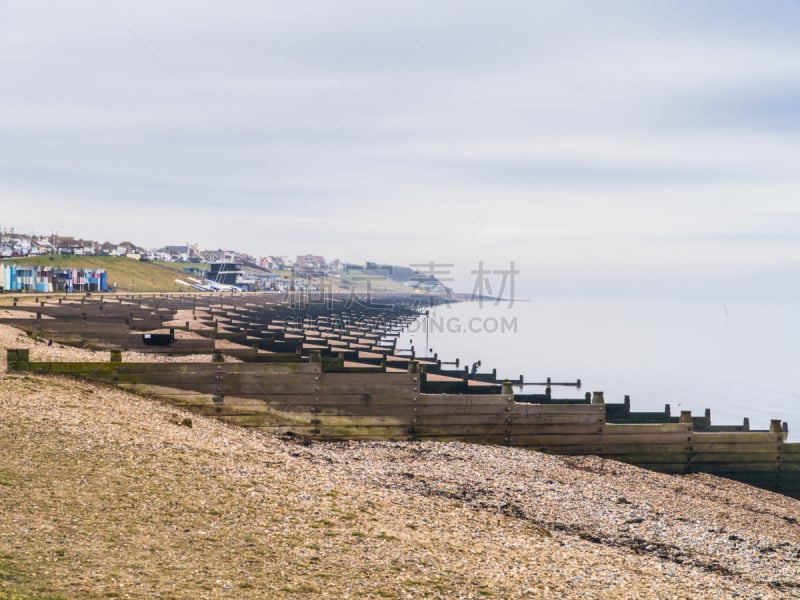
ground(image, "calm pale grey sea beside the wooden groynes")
xmin=400 ymin=298 xmax=800 ymax=441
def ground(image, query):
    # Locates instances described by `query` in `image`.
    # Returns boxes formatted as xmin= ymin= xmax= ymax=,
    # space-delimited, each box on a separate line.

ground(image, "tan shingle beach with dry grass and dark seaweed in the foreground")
xmin=0 ymin=326 xmax=800 ymax=598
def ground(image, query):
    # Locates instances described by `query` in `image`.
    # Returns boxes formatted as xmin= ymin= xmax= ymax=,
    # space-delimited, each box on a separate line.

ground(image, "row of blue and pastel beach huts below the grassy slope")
xmin=2 ymin=263 xmax=108 ymax=293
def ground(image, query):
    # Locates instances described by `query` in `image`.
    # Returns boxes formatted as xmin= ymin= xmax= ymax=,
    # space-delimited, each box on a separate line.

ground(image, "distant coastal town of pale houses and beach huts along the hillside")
xmin=0 ymin=229 xmax=450 ymax=294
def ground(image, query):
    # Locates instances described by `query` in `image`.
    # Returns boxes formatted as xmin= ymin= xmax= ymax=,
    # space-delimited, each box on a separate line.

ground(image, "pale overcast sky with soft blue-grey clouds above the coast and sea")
xmin=0 ymin=0 xmax=800 ymax=297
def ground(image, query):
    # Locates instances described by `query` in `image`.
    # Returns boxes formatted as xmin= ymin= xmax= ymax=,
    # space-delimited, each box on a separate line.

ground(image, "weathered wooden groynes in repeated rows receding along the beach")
xmin=0 ymin=294 xmax=800 ymax=497
